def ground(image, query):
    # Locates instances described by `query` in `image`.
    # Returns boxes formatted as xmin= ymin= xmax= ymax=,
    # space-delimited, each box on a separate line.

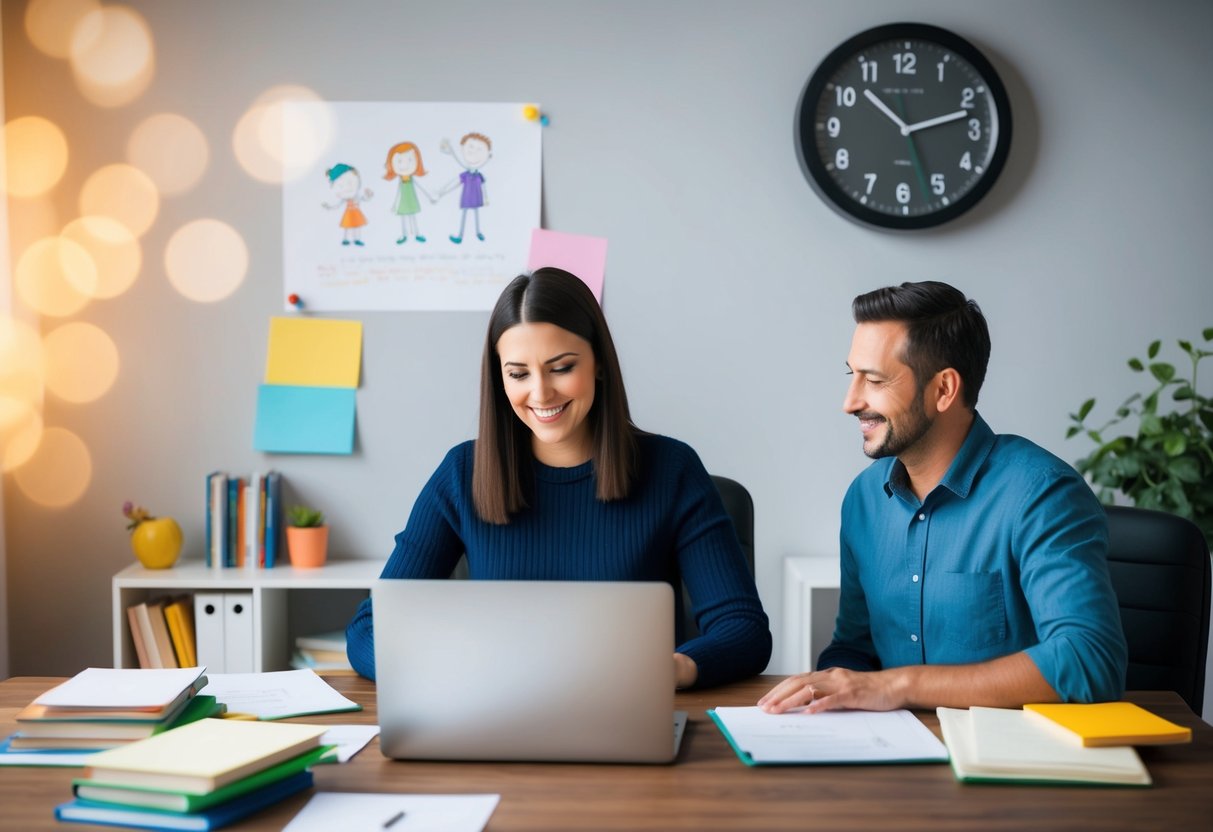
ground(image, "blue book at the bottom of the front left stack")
xmin=55 ymin=771 xmax=312 ymax=832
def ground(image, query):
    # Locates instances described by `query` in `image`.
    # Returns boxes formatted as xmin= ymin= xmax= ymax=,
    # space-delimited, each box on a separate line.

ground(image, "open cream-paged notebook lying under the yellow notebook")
xmin=936 ymin=707 xmax=1151 ymax=786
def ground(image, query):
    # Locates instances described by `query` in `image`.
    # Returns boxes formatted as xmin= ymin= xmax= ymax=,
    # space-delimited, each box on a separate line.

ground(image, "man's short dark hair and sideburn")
xmin=852 ymin=280 xmax=990 ymax=409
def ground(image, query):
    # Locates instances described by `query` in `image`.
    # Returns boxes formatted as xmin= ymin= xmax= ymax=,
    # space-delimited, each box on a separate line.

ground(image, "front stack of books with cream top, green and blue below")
xmin=55 ymin=719 xmax=335 ymax=830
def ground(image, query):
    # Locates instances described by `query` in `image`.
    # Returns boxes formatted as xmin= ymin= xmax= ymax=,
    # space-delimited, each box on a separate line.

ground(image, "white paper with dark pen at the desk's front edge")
xmin=283 ymin=792 xmax=501 ymax=832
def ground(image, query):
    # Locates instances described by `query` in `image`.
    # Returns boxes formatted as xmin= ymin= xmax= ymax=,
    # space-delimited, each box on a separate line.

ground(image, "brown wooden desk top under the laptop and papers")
xmin=0 ymin=677 xmax=1213 ymax=832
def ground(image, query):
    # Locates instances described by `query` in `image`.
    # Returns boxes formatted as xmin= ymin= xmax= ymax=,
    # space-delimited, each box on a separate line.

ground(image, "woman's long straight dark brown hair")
xmin=472 ymin=268 xmax=638 ymax=524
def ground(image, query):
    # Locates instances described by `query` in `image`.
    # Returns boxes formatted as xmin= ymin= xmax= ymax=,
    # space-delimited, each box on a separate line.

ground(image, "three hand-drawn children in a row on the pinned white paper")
xmin=323 ymin=133 xmax=492 ymax=245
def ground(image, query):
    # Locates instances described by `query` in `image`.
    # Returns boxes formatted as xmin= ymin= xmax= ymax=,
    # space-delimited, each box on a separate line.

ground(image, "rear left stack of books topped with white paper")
xmin=5 ymin=667 xmax=218 ymax=764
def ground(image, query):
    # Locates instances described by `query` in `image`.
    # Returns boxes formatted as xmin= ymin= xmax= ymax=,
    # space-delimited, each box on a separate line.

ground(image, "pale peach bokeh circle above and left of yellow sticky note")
xmin=164 ymin=220 xmax=249 ymax=303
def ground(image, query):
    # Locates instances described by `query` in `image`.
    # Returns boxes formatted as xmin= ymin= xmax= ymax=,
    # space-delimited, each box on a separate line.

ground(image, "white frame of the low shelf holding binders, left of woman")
xmin=112 ymin=560 xmax=383 ymax=673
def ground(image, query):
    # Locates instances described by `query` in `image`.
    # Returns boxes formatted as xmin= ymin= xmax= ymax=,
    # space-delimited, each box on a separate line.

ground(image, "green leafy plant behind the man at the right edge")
xmin=1066 ymin=327 xmax=1213 ymax=545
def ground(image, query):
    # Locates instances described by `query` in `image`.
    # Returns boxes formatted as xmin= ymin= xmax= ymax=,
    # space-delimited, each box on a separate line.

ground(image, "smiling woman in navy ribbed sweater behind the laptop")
xmin=347 ymin=268 xmax=770 ymax=688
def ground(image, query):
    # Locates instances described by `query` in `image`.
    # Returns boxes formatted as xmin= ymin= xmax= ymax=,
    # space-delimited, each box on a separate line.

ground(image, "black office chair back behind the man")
xmin=1107 ymin=506 xmax=1211 ymax=714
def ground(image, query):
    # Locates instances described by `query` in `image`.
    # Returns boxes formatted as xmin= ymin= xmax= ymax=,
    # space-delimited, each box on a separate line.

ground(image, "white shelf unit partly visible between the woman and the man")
xmin=784 ymin=558 xmax=839 ymax=673
